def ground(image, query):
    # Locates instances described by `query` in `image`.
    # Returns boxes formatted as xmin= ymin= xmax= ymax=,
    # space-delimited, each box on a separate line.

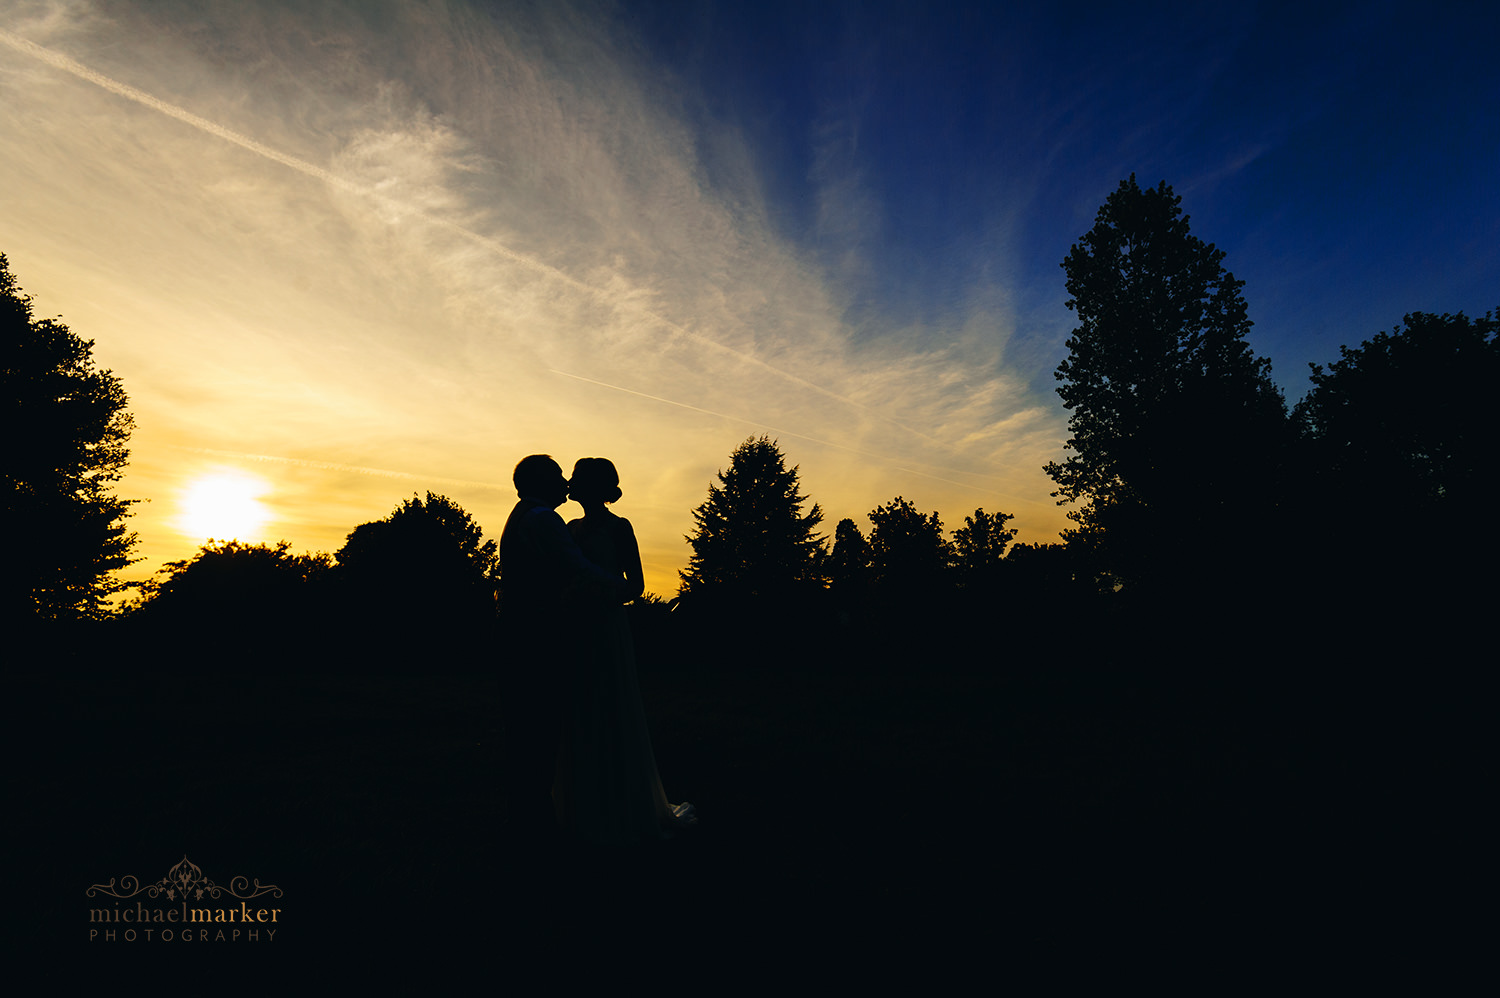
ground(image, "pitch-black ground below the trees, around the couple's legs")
xmin=12 ymin=603 xmax=1484 ymax=992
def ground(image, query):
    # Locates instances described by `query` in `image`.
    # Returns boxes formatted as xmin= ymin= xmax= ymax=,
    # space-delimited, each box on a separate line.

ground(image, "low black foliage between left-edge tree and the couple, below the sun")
xmin=125 ymin=492 xmax=498 ymax=674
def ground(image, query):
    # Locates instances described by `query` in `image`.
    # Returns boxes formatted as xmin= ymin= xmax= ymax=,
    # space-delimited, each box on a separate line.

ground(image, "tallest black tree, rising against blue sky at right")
xmin=1047 ymin=174 xmax=1287 ymax=581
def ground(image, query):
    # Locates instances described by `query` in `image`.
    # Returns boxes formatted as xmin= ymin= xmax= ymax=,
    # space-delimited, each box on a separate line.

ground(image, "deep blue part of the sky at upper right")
xmin=623 ymin=2 xmax=1500 ymax=402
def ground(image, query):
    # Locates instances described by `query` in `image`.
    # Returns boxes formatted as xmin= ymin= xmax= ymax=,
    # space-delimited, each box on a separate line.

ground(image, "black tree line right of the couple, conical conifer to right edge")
xmin=683 ymin=176 xmax=1500 ymax=624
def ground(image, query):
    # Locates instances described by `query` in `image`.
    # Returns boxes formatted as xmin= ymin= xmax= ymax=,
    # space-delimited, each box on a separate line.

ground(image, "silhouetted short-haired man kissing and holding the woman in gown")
xmin=500 ymin=453 xmax=633 ymax=840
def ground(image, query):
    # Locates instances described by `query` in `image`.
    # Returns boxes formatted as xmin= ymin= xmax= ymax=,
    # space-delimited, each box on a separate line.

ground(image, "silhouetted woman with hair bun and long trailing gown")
xmin=552 ymin=458 xmax=696 ymax=845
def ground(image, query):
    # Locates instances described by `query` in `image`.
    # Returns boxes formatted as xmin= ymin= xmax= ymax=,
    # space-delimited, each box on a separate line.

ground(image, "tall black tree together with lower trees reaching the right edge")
xmin=1047 ymin=176 xmax=1500 ymax=608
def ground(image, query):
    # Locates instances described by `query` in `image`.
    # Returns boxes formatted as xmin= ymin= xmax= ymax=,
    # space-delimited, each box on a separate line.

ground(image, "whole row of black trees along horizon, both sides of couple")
xmin=0 ymin=176 xmax=1500 ymax=645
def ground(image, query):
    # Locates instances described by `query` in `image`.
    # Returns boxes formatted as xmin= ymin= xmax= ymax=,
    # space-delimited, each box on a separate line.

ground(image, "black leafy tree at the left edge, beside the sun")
xmin=0 ymin=254 xmax=135 ymax=620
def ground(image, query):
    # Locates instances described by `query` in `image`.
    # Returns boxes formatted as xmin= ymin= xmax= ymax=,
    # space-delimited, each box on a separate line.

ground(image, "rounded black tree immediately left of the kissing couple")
xmin=335 ymin=492 xmax=500 ymax=632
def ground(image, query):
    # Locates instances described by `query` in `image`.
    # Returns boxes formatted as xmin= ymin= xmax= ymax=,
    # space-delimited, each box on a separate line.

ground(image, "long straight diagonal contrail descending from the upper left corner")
xmin=0 ymin=29 xmax=947 ymax=449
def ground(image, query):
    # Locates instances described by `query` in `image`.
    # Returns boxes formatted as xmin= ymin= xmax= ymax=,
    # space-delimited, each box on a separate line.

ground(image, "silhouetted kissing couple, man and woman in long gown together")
xmin=500 ymin=455 xmax=695 ymax=845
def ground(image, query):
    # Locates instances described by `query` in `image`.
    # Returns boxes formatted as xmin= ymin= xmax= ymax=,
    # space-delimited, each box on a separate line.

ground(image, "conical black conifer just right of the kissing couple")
xmin=678 ymin=437 xmax=825 ymax=596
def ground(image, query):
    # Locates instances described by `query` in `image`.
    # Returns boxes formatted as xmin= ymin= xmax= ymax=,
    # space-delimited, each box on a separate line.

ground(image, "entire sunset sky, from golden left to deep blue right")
xmin=0 ymin=0 xmax=1500 ymax=579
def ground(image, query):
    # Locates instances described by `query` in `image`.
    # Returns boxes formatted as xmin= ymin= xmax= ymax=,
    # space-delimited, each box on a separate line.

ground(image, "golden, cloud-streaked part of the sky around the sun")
xmin=0 ymin=2 xmax=1082 ymax=596
